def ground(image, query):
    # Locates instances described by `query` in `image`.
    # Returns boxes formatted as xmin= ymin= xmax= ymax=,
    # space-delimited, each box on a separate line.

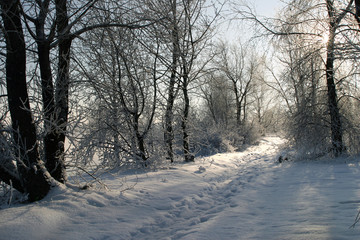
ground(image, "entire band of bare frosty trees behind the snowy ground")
xmin=0 ymin=0 xmax=360 ymax=201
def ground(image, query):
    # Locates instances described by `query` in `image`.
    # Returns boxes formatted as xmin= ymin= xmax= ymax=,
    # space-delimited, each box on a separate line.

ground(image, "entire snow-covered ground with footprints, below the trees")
xmin=0 ymin=137 xmax=360 ymax=240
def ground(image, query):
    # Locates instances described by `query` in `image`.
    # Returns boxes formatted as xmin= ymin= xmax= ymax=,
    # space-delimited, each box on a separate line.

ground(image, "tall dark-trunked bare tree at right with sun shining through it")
xmin=236 ymin=0 xmax=354 ymax=156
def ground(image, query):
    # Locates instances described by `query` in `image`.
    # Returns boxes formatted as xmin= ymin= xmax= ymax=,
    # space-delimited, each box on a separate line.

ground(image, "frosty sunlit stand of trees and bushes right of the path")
xmin=239 ymin=0 xmax=360 ymax=158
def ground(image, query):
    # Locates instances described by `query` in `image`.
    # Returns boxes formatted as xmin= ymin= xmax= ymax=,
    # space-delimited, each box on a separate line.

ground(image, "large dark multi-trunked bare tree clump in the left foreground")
xmin=0 ymin=0 xmax=161 ymax=201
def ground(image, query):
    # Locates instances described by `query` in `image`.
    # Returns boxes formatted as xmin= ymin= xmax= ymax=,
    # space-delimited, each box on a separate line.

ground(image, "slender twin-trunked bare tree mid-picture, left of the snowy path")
xmin=141 ymin=0 xmax=219 ymax=162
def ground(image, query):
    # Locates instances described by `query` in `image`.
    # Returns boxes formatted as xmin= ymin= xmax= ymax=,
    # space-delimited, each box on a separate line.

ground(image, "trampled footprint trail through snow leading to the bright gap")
xmin=131 ymin=138 xmax=290 ymax=239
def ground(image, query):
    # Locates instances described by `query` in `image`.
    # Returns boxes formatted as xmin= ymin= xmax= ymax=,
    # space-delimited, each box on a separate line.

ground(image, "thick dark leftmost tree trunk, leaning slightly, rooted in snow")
xmin=1 ymin=0 xmax=50 ymax=201
